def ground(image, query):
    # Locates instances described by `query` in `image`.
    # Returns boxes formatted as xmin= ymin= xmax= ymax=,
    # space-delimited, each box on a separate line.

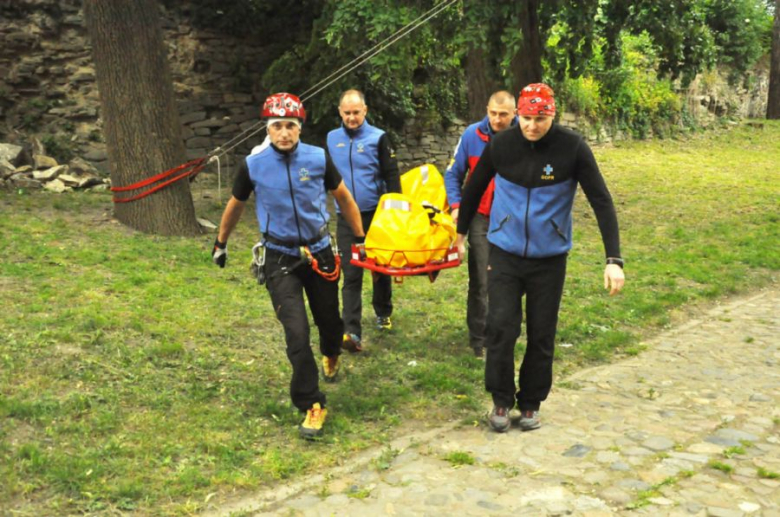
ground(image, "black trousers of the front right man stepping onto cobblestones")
xmin=485 ymin=245 xmax=567 ymax=410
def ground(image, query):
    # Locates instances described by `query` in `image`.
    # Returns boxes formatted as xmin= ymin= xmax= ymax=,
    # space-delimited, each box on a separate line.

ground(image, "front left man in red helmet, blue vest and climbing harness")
xmin=212 ymin=93 xmax=365 ymax=439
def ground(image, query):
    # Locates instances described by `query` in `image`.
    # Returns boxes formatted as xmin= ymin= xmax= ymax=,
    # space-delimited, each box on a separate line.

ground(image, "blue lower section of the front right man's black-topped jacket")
xmin=488 ymin=174 xmax=577 ymax=258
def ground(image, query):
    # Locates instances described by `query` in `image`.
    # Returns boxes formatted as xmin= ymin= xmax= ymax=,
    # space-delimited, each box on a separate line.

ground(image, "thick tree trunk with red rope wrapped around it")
xmin=84 ymin=0 xmax=200 ymax=235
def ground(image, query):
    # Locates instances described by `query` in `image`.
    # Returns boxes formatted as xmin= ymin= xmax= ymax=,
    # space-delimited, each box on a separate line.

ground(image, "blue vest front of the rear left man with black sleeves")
xmin=328 ymin=121 xmax=385 ymax=212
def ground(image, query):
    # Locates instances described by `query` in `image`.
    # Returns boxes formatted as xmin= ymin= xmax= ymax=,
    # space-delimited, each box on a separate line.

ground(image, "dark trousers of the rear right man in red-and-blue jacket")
xmin=466 ymin=214 xmax=490 ymax=348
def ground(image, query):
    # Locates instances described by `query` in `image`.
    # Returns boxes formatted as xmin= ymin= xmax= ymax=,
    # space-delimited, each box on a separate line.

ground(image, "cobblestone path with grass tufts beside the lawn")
xmin=213 ymin=290 xmax=780 ymax=517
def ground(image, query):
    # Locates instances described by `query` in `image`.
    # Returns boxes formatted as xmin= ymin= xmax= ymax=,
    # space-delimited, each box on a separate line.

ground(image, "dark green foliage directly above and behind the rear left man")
xmin=263 ymin=0 xmax=464 ymax=141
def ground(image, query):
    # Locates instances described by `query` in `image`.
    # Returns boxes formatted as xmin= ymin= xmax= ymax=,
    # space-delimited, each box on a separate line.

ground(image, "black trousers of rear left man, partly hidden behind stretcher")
xmin=336 ymin=212 xmax=393 ymax=336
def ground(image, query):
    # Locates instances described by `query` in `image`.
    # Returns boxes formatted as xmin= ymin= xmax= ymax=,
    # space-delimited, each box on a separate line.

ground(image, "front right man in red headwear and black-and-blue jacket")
xmin=456 ymin=83 xmax=625 ymax=432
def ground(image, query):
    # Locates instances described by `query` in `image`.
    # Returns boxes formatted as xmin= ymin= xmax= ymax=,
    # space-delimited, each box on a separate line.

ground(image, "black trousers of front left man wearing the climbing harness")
xmin=265 ymin=247 xmax=344 ymax=411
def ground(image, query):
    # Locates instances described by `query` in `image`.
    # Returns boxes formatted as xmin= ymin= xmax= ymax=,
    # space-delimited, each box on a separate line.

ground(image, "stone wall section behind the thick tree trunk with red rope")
xmin=0 ymin=0 xmax=269 ymax=172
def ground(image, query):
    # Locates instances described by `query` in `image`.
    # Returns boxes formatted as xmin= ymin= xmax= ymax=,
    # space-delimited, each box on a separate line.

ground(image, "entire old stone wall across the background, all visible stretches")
xmin=0 ymin=0 xmax=768 ymax=181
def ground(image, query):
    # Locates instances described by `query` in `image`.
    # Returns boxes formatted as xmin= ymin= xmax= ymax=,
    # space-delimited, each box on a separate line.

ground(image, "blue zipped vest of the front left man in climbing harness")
xmin=246 ymin=143 xmax=330 ymax=255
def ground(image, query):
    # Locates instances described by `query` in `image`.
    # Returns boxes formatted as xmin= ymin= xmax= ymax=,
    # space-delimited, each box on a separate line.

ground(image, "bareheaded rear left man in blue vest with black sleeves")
xmin=328 ymin=90 xmax=401 ymax=352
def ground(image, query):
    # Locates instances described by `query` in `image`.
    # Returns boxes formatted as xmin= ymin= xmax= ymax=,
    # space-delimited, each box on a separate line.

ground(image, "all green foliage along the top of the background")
xmin=166 ymin=0 xmax=772 ymax=140
